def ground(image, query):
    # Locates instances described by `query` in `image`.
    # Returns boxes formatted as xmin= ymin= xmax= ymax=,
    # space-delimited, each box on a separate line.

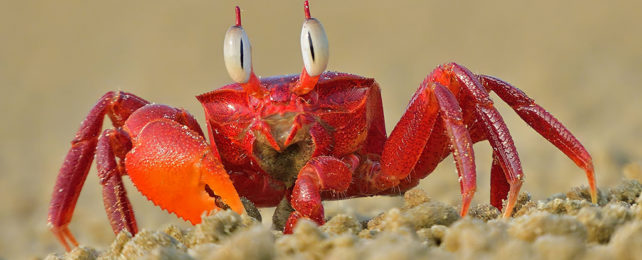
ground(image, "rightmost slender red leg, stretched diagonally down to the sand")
xmin=479 ymin=75 xmax=597 ymax=203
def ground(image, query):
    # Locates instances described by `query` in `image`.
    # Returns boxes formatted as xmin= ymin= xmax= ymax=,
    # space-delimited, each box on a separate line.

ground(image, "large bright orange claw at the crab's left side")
xmin=126 ymin=119 xmax=244 ymax=224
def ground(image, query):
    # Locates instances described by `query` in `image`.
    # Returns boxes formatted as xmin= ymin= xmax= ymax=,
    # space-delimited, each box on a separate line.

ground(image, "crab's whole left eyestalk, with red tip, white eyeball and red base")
xmin=223 ymin=6 xmax=267 ymax=98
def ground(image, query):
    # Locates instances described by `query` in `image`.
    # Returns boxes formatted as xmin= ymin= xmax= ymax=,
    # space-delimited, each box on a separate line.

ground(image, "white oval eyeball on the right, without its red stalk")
xmin=301 ymin=18 xmax=330 ymax=77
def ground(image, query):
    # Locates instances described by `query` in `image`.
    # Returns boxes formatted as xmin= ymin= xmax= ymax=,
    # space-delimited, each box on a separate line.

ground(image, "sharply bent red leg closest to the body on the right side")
xmin=372 ymin=78 xmax=477 ymax=216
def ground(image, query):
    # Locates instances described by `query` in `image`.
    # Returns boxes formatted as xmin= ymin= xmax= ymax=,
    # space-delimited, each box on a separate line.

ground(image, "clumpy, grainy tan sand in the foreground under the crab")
xmin=46 ymin=180 xmax=642 ymax=259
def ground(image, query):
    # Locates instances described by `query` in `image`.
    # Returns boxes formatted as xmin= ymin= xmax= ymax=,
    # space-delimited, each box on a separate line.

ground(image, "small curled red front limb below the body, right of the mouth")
xmin=283 ymin=156 xmax=352 ymax=234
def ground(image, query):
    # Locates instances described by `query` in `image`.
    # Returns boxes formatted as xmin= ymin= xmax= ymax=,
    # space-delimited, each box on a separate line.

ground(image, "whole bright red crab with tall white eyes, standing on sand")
xmin=48 ymin=1 xmax=596 ymax=250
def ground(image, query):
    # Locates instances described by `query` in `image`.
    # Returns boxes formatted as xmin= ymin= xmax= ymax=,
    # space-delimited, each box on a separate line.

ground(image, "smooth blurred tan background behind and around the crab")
xmin=0 ymin=0 xmax=642 ymax=259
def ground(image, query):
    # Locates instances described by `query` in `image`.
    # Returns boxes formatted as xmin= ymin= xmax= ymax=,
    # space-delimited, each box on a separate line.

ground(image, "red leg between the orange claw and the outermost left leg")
xmin=96 ymin=129 xmax=138 ymax=235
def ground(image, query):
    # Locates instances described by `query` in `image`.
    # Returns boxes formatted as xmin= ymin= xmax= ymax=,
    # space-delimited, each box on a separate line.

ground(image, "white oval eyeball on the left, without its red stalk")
xmin=223 ymin=26 xmax=252 ymax=83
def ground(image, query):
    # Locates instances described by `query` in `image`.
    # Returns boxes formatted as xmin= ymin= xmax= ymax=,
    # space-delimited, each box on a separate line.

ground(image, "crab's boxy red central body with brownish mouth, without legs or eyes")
xmin=198 ymin=72 xmax=386 ymax=207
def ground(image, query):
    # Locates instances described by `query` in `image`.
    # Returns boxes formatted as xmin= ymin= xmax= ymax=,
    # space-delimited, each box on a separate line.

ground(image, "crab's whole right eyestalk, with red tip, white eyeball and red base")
xmin=292 ymin=1 xmax=330 ymax=95
